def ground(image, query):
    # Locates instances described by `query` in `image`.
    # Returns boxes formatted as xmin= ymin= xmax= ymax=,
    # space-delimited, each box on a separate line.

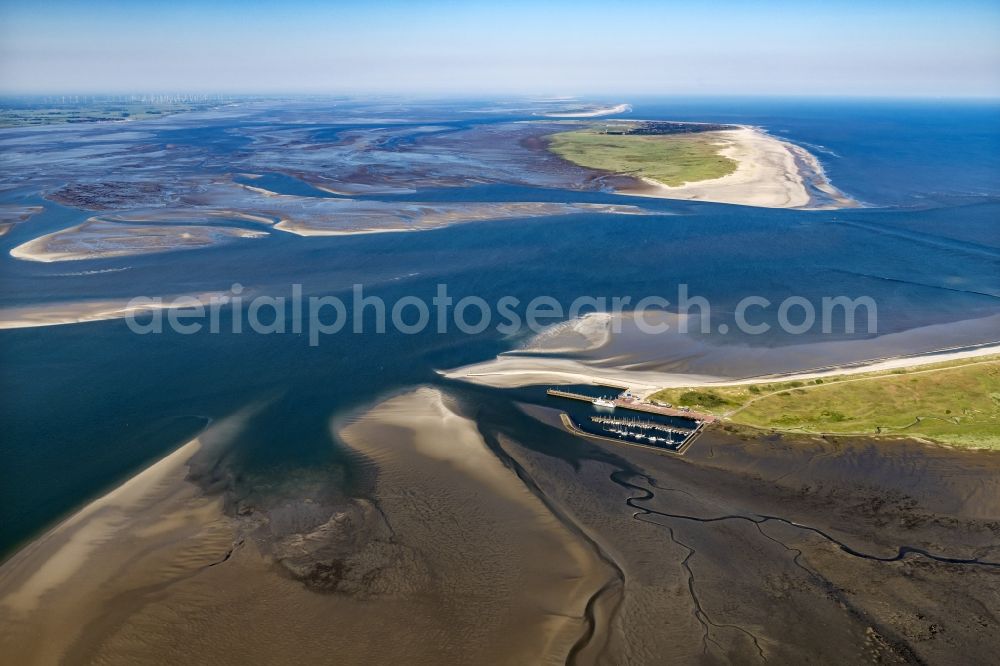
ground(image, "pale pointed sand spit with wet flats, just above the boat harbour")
xmin=441 ymin=313 xmax=1000 ymax=395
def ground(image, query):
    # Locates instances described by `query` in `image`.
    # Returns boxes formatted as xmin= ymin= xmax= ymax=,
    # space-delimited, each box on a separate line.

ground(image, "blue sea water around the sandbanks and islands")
xmin=0 ymin=99 xmax=1000 ymax=553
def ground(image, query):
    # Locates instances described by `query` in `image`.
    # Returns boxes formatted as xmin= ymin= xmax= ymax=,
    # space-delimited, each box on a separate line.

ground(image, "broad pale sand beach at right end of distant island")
xmin=622 ymin=127 xmax=856 ymax=208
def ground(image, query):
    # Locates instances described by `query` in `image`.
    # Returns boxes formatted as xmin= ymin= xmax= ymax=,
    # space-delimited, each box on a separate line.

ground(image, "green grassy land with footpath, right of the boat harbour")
xmin=652 ymin=356 xmax=1000 ymax=450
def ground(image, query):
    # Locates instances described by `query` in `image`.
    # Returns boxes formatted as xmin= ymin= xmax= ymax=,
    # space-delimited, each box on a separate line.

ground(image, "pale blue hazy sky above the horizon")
xmin=0 ymin=0 xmax=1000 ymax=97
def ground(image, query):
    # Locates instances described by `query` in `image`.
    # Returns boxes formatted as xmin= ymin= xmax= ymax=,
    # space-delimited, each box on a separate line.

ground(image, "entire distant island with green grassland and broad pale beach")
xmin=547 ymin=121 xmax=857 ymax=208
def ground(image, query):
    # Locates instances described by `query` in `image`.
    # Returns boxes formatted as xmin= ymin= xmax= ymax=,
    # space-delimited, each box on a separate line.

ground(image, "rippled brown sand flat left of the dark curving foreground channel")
xmin=0 ymin=390 xmax=611 ymax=666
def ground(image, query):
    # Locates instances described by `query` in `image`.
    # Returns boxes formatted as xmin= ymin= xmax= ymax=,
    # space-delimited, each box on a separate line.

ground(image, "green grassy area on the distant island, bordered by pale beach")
xmin=549 ymin=130 xmax=737 ymax=187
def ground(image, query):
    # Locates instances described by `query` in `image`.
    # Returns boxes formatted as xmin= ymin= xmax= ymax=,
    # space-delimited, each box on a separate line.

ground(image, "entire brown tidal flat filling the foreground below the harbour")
xmin=0 ymin=360 xmax=1000 ymax=666
